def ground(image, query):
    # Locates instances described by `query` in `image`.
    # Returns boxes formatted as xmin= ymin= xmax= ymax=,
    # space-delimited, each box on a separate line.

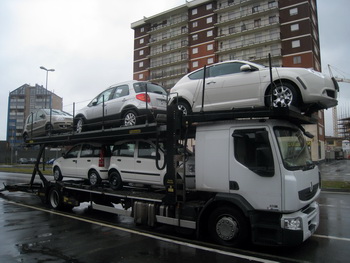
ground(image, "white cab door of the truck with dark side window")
xmin=230 ymin=128 xmax=282 ymax=210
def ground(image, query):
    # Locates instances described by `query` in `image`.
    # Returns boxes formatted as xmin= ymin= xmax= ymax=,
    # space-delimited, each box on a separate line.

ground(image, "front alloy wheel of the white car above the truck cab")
xmin=266 ymin=83 xmax=299 ymax=108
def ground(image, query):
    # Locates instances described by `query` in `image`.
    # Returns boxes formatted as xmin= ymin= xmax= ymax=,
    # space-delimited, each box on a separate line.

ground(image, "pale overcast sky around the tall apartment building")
xmin=0 ymin=0 xmax=350 ymax=140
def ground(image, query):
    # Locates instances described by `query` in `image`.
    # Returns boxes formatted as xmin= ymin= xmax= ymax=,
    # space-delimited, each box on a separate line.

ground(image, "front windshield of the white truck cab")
xmin=275 ymin=127 xmax=315 ymax=170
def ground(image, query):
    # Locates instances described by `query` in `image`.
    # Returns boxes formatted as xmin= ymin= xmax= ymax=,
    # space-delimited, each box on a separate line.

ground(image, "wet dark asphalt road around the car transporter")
xmin=0 ymin=161 xmax=350 ymax=263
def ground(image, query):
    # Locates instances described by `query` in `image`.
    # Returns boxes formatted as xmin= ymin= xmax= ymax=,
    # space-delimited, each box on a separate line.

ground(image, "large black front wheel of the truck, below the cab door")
xmin=208 ymin=207 xmax=249 ymax=247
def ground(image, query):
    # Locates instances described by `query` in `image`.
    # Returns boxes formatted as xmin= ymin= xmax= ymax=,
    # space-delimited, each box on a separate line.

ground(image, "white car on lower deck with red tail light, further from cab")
xmin=52 ymin=143 xmax=111 ymax=185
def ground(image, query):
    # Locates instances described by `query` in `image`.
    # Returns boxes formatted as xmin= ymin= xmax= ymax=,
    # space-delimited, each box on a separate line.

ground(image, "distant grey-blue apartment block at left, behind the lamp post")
xmin=7 ymin=84 xmax=63 ymax=146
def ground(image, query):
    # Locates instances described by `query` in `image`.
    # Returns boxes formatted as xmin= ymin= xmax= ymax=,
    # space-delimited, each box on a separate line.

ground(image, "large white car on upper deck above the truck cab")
xmin=169 ymin=60 xmax=339 ymax=114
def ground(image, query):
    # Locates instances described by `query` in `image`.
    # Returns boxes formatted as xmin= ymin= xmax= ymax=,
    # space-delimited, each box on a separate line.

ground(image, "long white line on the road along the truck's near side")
xmin=6 ymin=200 xmax=280 ymax=263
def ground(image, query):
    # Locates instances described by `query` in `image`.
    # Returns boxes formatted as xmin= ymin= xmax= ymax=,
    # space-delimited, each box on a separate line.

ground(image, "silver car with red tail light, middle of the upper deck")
xmin=74 ymin=80 xmax=167 ymax=133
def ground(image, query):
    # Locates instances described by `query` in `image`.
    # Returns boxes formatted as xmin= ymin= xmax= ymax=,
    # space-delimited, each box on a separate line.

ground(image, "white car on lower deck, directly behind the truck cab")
xmin=108 ymin=139 xmax=195 ymax=190
